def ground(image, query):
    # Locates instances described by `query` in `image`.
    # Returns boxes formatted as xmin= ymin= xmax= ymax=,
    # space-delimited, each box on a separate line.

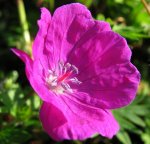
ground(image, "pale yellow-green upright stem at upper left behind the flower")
xmin=16 ymin=0 xmax=31 ymax=51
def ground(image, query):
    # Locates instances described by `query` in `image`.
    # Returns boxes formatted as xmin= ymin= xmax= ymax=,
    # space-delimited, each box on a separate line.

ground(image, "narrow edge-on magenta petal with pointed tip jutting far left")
xmin=11 ymin=49 xmax=63 ymax=108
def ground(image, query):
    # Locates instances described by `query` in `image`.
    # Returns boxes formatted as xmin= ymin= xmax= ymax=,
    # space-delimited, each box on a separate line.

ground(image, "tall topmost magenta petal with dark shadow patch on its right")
xmin=46 ymin=3 xmax=94 ymax=67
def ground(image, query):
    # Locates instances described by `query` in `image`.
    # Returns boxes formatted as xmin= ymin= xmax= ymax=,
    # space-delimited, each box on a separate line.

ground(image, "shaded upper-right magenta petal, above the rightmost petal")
xmin=68 ymin=30 xmax=131 ymax=70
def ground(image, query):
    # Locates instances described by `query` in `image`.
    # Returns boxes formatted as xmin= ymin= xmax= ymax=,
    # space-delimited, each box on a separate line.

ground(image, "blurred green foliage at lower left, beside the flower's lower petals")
xmin=0 ymin=71 xmax=40 ymax=144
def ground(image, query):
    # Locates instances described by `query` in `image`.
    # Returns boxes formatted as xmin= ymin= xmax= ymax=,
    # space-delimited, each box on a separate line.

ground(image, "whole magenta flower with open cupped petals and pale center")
xmin=13 ymin=3 xmax=140 ymax=141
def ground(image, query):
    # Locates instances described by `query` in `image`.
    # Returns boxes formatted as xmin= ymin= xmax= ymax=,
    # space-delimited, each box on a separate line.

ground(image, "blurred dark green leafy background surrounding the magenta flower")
xmin=0 ymin=0 xmax=150 ymax=144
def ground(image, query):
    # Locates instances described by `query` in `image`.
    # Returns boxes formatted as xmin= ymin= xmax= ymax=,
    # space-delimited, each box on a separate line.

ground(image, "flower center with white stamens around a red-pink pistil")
xmin=45 ymin=62 xmax=81 ymax=94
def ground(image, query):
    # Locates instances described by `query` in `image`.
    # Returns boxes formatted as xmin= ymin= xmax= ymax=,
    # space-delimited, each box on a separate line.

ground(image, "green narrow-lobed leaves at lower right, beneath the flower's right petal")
xmin=114 ymin=82 xmax=150 ymax=144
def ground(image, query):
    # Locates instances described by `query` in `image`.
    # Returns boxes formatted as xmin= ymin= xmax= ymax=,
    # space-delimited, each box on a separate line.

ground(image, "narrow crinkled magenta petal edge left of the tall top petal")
xmin=32 ymin=8 xmax=52 ymax=70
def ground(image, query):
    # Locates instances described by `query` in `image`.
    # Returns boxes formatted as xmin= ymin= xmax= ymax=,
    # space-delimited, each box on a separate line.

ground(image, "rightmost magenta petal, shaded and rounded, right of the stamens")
xmin=77 ymin=63 xmax=140 ymax=109
